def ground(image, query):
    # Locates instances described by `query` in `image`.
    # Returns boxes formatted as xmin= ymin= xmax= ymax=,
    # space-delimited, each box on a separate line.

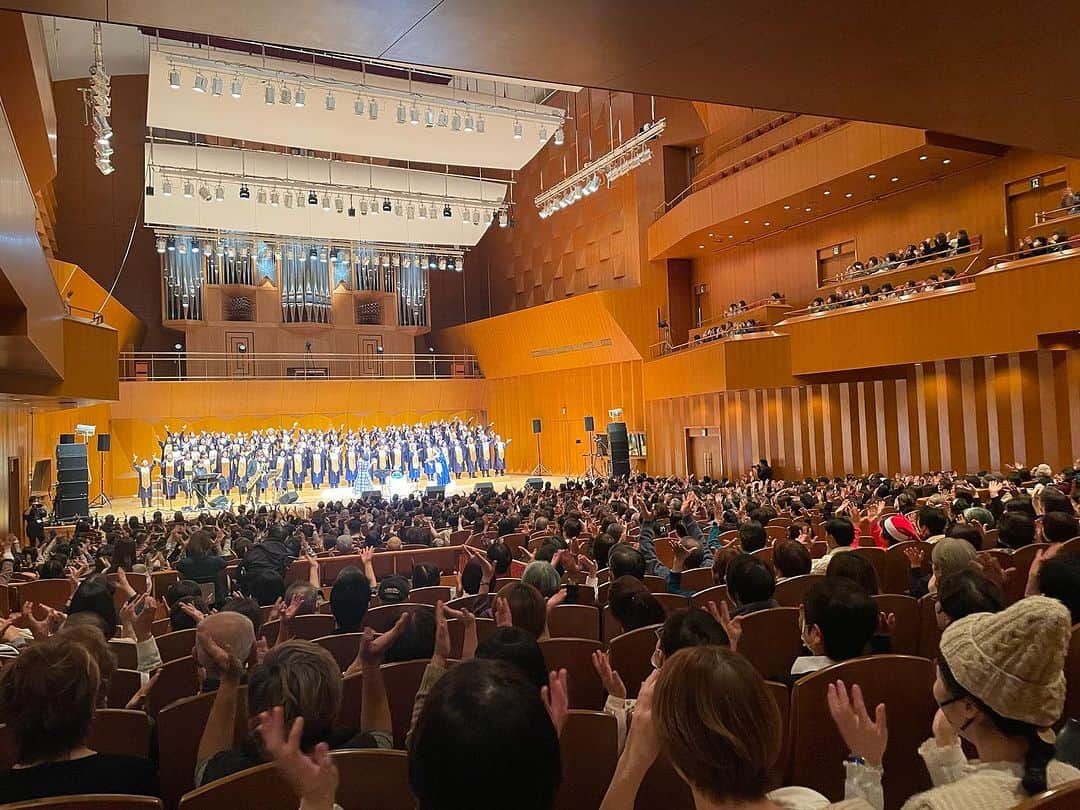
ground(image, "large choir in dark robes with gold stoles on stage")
xmin=132 ymin=418 xmax=510 ymax=507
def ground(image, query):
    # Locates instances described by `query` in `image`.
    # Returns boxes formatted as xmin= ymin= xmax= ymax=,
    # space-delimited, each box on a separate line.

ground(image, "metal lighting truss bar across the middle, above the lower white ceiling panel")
xmin=147 ymin=162 xmax=510 ymax=219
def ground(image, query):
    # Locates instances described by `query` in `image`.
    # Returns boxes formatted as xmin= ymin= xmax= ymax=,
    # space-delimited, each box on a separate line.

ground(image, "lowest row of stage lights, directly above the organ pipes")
xmin=153 ymin=228 xmax=465 ymax=272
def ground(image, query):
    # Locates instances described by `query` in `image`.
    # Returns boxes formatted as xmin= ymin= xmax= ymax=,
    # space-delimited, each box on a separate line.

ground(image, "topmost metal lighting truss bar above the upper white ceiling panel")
xmin=159 ymin=49 xmax=566 ymax=133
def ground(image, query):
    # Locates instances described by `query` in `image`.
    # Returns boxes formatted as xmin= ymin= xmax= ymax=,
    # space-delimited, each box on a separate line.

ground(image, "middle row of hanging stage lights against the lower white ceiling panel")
xmin=147 ymin=163 xmax=511 ymax=228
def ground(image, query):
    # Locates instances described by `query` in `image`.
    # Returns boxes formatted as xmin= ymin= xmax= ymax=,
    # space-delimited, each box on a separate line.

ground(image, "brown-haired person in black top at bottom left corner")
xmin=0 ymin=636 xmax=158 ymax=802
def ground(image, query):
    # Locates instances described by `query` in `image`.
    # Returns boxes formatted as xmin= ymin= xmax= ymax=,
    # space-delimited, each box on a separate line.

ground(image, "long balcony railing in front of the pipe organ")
xmin=120 ymin=351 xmax=483 ymax=381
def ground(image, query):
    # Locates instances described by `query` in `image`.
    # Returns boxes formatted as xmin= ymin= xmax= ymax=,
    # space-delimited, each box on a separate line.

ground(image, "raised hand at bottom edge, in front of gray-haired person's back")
xmin=258 ymin=706 xmax=339 ymax=810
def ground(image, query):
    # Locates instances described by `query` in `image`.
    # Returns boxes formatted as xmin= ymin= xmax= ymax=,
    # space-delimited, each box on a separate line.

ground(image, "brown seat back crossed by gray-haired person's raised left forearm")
xmin=157 ymin=686 xmax=247 ymax=810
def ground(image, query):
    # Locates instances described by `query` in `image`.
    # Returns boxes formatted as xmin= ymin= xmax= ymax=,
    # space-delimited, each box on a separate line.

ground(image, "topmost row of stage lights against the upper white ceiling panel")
xmin=161 ymin=51 xmax=566 ymax=145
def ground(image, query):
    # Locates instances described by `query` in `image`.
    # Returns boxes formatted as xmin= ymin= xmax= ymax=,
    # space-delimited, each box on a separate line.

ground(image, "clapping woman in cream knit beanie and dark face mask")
xmin=828 ymin=596 xmax=1080 ymax=810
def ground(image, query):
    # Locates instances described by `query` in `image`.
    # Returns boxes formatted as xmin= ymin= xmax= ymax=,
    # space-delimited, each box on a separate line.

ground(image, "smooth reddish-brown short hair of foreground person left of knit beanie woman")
xmin=652 ymin=645 xmax=782 ymax=801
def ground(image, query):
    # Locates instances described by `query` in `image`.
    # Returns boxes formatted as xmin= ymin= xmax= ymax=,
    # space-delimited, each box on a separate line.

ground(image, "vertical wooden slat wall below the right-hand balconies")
xmin=646 ymin=349 xmax=1080 ymax=477
